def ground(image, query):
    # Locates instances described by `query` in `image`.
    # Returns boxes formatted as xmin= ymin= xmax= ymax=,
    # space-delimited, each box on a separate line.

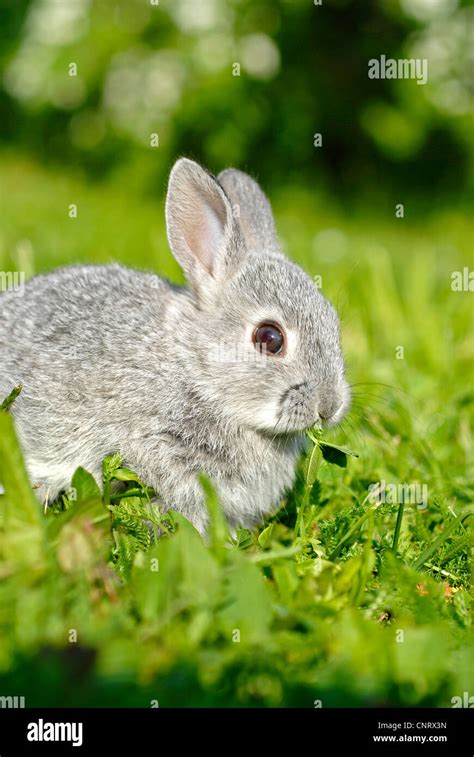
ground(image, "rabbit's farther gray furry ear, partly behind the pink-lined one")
xmin=217 ymin=168 xmax=280 ymax=253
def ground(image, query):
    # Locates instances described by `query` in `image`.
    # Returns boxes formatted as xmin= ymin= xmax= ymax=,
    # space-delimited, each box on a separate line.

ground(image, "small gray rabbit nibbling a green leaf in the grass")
xmin=0 ymin=159 xmax=349 ymax=533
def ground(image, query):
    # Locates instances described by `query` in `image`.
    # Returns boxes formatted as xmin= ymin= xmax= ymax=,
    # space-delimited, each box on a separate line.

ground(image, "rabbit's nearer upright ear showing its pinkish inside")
xmin=166 ymin=158 xmax=244 ymax=297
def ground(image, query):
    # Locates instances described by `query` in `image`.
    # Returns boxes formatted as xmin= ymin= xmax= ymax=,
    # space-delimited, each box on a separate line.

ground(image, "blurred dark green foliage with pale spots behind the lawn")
xmin=0 ymin=0 xmax=473 ymax=209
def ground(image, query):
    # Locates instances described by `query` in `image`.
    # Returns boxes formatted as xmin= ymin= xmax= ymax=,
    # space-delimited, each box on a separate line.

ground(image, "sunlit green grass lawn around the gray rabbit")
xmin=0 ymin=155 xmax=473 ymax=707
